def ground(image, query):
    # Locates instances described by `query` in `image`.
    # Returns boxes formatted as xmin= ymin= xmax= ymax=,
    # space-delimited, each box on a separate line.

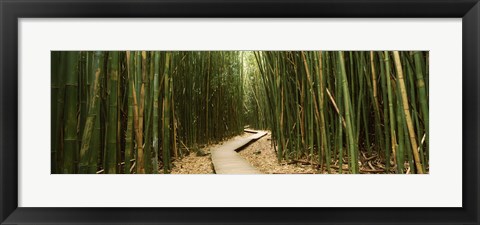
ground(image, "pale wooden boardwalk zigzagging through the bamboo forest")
xmin=211 ymin=129 xmax=267 ymax=174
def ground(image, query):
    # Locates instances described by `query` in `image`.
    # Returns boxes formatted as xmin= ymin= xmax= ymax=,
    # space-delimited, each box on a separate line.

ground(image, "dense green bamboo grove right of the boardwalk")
xmin=254 ymin=51 xmax=429 ymax=173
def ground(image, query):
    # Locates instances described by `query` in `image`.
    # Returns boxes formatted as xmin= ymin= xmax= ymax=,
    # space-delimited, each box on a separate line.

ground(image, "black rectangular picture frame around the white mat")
xmin=0 ymin=0 xmax=480 ymax=224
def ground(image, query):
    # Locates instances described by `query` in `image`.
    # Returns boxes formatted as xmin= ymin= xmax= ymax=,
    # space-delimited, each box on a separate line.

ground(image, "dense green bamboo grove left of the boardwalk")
xmin=51 ymin=51 xmax=244 ymax=174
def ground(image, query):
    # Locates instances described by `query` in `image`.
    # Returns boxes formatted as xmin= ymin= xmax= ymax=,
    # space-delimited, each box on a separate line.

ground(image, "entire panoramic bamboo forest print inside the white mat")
xmin=51 ymin=51 xmax=430 ymax=174
